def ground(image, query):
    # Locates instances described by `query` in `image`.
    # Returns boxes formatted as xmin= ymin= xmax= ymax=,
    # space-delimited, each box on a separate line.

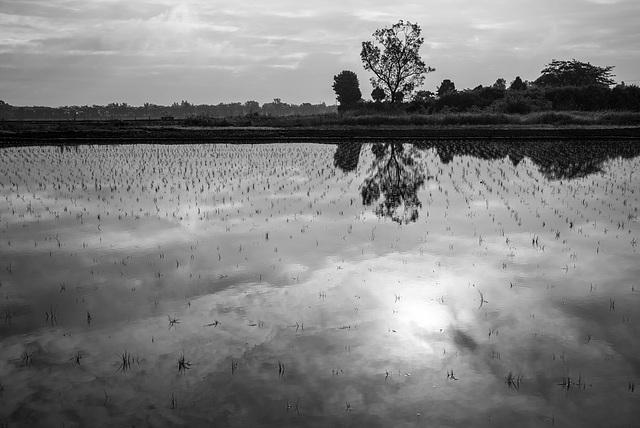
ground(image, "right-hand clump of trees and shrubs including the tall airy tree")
xmin=334 ymin=20 xmax=640 ymax=118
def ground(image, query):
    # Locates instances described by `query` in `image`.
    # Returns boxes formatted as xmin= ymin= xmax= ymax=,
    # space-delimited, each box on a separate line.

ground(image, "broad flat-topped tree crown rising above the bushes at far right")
xmin=535 ymin=59 xmax=615 ymax=87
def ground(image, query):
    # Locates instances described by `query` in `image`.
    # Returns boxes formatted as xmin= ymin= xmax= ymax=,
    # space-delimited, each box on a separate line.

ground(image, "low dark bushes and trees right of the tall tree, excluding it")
xmin=340 ymin=52 xmax=640 ymax=115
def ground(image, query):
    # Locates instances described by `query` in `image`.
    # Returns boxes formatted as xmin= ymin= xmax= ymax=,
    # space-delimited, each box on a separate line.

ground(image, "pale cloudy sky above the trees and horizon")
xmin=0 ymin=0 xmax=640 ymax=106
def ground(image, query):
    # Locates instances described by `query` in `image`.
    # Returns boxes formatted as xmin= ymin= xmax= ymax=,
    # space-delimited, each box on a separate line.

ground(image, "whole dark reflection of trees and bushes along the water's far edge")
xmin=334 ymin=139 xmax=640 ymax=224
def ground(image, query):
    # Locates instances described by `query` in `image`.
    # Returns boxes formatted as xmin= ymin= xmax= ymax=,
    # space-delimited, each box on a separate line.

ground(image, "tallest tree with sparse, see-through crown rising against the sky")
xmin=360 ymin=20 xmax=435 ymax=103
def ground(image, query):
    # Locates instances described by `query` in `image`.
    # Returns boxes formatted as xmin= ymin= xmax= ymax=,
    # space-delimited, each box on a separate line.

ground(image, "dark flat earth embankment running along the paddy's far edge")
xmin=0 ymin=124 xmax=640 ymax=147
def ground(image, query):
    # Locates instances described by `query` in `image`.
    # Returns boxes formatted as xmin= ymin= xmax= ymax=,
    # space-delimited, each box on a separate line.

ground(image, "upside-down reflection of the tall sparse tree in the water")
xmin=360 ymin=143 xmax=427 ymax=224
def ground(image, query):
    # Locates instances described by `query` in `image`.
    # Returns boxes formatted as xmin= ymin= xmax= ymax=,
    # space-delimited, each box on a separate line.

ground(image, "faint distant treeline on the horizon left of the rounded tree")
xmin=0 ymin=98 xmax=337 ymax=120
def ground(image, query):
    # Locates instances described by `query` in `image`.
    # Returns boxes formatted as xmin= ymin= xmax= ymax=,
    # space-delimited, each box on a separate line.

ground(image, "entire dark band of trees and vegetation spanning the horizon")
xmin=0 ymin=20 xmax=640 ymax=124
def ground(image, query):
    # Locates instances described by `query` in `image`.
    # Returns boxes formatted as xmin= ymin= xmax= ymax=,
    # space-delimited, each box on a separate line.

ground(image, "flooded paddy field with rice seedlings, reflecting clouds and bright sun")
xmin=0 ymin=140 xmax=640 ymax=427
